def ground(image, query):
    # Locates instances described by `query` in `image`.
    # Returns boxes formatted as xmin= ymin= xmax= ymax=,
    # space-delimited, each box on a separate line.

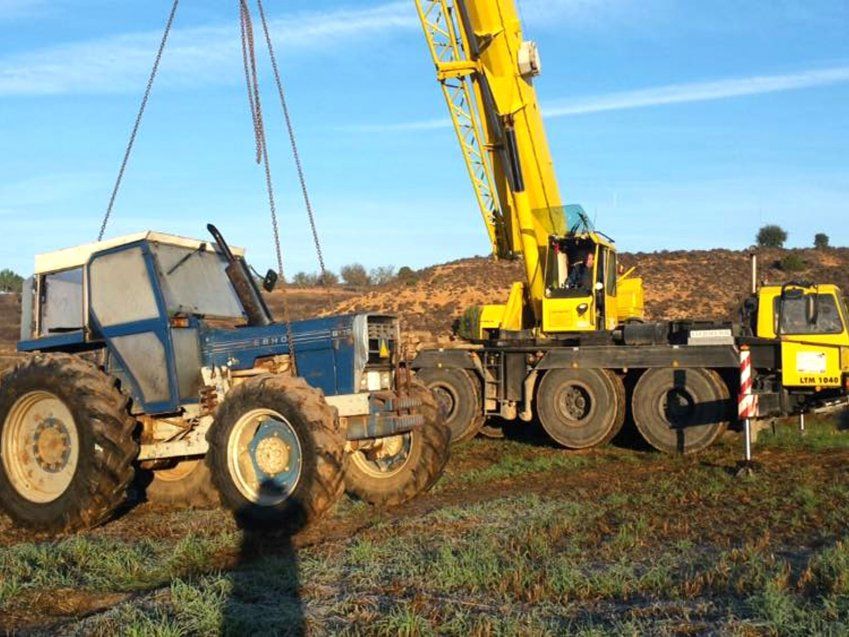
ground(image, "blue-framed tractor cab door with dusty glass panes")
xmin=87 ymin=242 xmax=180 ymax=413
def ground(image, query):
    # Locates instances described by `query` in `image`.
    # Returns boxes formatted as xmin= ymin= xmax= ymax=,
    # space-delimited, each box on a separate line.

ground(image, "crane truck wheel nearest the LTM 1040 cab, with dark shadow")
xmin=631 ymin=368 xmax=731 ymax=454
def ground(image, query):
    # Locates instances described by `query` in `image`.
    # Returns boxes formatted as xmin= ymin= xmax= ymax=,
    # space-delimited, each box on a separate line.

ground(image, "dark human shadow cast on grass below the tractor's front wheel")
xmin=219 ymin=485 xmax=307 ymax=637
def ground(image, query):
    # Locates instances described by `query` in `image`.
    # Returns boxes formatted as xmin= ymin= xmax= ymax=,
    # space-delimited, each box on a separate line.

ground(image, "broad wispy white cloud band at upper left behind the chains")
xmin=0 ymin=0 xmax=418 ymax=96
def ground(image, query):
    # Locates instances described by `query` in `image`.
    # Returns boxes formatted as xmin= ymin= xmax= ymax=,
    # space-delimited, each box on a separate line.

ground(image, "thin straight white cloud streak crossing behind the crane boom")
xmin=345 ymin=66 xmax=849 ymax=133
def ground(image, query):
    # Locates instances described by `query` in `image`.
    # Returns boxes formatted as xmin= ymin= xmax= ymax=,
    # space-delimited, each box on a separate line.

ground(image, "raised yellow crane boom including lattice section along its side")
xmin=416 ymin=0 xmax=566 ymax=318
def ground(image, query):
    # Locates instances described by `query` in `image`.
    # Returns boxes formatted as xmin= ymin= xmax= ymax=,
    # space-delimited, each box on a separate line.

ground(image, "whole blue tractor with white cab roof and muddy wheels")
xmin=0 ymin=226 xmax=450 ymax=532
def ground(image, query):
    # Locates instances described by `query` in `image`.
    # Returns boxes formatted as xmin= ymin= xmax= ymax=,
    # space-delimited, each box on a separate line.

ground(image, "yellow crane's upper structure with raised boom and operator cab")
xmin=416 ymin=0 xmax=643 ymax=340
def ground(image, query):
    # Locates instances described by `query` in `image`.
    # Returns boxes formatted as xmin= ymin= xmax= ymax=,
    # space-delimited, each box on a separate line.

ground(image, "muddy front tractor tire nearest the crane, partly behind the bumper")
xmin=345 ymin=381 xmax=451 ymax=507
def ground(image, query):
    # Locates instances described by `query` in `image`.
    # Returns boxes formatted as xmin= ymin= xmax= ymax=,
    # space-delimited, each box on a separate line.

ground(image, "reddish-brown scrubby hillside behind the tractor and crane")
xmin=0 ymin=248 xmax=849 ymax=353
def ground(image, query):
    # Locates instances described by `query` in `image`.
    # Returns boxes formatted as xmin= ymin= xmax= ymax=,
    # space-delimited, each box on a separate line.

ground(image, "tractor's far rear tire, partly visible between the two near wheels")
xmin=145 ymin=458 xmax=221 ymax=509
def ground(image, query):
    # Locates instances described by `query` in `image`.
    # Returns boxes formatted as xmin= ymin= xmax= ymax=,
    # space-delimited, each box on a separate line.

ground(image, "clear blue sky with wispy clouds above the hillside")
xmin=0 ymin=0 xmax=849 ymax=272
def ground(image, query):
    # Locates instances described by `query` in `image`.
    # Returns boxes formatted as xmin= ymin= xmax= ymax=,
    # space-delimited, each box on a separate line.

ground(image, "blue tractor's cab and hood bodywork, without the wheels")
xmin=18 ymin=228 xmax=400 ymax=414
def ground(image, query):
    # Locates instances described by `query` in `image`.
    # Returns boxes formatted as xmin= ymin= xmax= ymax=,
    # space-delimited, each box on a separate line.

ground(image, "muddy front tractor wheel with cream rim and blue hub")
xmin=207 ymin=374 xmax=346 ymax=533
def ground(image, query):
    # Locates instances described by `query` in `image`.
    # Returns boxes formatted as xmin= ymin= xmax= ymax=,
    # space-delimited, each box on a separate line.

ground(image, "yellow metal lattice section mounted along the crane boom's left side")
xmin=416 ymin=0 xmax=512 ymax=257
